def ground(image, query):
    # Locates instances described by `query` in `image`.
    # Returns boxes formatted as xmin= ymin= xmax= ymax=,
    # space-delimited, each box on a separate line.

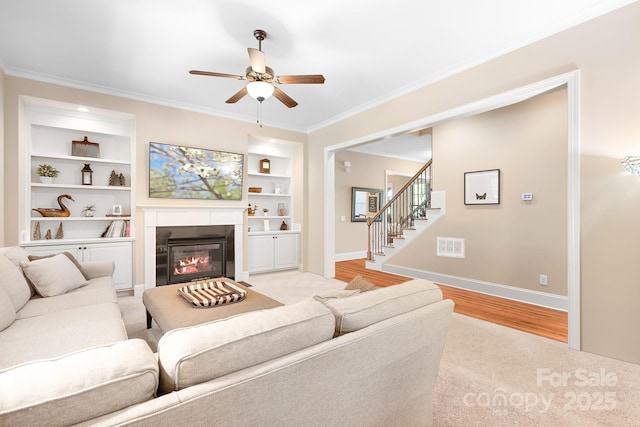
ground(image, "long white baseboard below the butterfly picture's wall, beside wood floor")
xmin=382 ymin=264 xmax=569 ymax=311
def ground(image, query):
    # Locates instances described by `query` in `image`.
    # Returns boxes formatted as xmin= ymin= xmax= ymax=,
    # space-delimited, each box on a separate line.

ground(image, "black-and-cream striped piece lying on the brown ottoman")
xmin=178 ymin=278 xmax=247 ymax=308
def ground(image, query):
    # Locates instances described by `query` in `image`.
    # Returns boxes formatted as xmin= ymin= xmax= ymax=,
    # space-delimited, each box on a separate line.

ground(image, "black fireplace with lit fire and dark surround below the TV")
xmin=156 ymin=225 xmax=235 ymax=286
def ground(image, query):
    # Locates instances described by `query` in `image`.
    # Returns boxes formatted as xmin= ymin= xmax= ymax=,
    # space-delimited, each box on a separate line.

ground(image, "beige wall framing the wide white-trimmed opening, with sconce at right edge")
xmin=307 ymin=2 xmax=640 ymax=363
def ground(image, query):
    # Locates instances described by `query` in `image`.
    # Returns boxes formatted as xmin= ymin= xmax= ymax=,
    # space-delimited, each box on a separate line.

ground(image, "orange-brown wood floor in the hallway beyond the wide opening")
xmin=336 ymin=259 xmax=568 ymax=342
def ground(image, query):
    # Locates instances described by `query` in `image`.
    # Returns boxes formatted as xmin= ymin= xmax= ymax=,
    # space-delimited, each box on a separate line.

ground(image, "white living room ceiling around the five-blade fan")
xmin=0 ymin=0 xmax=633 ymax=132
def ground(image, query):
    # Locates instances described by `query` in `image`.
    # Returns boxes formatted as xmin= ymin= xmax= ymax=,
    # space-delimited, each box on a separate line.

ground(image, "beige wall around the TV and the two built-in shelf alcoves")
xmin=3 ymin=76 xmax=306 ymax=283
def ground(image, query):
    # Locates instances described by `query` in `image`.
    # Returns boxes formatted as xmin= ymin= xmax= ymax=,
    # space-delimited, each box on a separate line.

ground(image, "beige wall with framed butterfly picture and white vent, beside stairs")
xmin=389 ymin=89 xmax=567 ymax=295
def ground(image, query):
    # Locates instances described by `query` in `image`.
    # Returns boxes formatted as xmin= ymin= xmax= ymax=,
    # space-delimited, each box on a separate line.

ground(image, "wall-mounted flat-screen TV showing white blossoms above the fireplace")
xmin=149 ymin=142 xmax=244 ymax=200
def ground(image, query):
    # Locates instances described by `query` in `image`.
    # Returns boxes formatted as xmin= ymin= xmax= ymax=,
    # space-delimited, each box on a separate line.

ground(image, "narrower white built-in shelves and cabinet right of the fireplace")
xmin=247 ymin=142 xmax=300 ymax=273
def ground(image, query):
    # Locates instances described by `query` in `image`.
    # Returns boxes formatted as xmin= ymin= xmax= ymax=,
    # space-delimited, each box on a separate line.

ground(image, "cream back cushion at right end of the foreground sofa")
xmin=325 ymin=279 xmax=442 ymax=335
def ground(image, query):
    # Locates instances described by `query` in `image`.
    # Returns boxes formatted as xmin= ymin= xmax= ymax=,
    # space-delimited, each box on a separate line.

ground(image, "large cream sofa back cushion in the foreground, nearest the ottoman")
xmin=158 ymin=298 xmax=335 ymax=393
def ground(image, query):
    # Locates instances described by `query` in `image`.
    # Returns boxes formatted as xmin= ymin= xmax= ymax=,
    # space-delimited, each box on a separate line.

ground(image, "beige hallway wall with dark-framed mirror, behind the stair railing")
xmin=334 ymin=151 xmax=422 ymax=254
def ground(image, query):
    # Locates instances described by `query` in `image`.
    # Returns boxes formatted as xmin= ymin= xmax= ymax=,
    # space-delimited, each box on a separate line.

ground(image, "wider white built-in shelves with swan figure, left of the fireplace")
xmin=20 ymin=97 xmax=135 ymax=290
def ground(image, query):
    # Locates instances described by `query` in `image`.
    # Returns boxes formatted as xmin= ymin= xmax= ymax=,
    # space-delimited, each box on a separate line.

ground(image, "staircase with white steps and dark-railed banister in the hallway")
xmin=366 ymin=160 xmax=444 ymax=271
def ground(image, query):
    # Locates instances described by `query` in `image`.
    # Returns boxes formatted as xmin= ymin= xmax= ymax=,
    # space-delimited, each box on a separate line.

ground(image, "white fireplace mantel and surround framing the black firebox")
xmin=138 ymin=206 xmax=249 ymax=289
